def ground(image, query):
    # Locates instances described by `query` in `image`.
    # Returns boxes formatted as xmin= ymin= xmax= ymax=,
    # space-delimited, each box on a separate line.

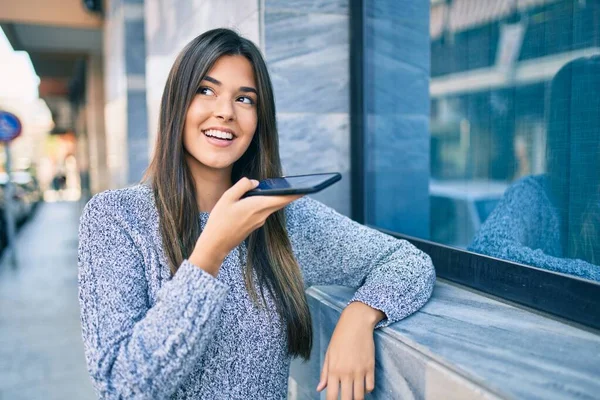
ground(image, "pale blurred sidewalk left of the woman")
xmin=0 ymin=202 xmax=96 ymax=400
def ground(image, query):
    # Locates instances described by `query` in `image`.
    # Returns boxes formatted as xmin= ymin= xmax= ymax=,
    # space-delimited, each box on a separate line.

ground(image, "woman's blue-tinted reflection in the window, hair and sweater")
xmin=471 ymin=56 xmax=600 ymax=281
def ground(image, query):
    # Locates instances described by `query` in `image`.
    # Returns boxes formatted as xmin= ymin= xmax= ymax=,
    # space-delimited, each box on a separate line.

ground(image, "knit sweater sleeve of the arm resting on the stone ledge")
xmin=286 ymin=197 xmax=435 ymax=327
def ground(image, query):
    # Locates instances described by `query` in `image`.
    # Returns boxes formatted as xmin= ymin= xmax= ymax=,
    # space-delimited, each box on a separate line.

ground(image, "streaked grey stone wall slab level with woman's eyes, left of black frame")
xmin=265 ymin=9 xmax=349 ymax=113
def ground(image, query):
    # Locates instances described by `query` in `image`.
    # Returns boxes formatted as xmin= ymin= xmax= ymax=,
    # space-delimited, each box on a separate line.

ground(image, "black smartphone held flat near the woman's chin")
xmin=242 ymin=172 xmax=342 ymax=197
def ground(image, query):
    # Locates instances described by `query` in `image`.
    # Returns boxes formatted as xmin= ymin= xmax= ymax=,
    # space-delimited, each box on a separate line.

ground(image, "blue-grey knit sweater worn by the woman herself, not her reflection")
xmin=79 ymin=185 xmax=435 ymax=399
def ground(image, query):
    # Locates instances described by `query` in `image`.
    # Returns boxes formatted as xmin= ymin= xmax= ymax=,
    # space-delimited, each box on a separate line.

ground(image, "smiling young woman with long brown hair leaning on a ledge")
xmin=79 ymin=29 xmax=435 ymax=399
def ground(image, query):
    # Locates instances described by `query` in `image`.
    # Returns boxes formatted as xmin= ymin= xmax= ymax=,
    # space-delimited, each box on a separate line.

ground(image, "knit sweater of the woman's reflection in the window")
xmin=469 ymin=175 xmax=600 ymax=281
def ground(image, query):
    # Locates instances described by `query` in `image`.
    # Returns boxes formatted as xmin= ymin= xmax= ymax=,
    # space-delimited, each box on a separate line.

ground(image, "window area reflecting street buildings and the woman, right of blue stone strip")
xmin=429 ymin=0 xmax=600 ymax=281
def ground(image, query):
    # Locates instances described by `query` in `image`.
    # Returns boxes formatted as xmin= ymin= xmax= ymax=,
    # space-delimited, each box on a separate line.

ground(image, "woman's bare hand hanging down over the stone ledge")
xmin=317 ymin=302 xmax=385 ymax=400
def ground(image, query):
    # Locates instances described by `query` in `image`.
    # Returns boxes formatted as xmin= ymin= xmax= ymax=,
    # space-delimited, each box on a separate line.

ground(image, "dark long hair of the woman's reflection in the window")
xmin=547 ymin=56 xmax=600 ymax=264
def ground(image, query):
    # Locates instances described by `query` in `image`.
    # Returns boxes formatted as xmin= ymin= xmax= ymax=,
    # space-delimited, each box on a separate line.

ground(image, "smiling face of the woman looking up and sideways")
xmin=183 ymin=55 xmax=258 ymax=175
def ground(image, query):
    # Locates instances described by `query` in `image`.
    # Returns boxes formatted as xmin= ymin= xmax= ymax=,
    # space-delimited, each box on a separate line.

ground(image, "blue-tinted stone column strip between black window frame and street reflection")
xmin=364 ymin=0 xmax=430 ymax=238
